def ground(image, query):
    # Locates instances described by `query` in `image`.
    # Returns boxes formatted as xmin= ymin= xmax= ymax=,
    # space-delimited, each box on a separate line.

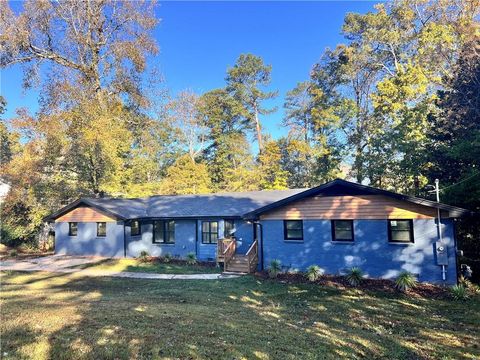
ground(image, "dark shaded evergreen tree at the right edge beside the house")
xmin=427 ymin=34 xmax=480 ymax=282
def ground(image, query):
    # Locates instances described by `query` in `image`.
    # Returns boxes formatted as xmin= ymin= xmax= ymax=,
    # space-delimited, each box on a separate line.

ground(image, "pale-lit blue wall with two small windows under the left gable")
xmin=55 ymin=221 xmax=124 ymax=257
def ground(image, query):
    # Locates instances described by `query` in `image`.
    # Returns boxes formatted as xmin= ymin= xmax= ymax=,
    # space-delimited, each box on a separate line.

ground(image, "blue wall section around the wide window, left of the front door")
xmin=125 ymin=220 xmax=195 ymax=258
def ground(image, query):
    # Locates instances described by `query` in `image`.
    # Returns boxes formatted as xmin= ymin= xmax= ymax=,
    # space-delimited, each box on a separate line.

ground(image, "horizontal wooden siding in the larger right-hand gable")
xmin=260 ymin=195 xmax=437 ymax=220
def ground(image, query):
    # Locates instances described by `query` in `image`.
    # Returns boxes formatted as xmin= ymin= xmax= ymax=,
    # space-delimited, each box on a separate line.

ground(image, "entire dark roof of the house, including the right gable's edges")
xmin=45 ymin=179 xmax=474 ymax=221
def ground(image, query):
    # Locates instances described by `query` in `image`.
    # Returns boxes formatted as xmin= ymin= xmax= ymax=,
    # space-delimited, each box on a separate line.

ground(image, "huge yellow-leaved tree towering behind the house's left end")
xmin=0 ymin=0 xmax=166 ymax=246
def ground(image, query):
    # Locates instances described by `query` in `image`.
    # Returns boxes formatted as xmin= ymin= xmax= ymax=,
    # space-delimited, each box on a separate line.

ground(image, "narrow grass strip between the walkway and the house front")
xmin=66 ymin=259 xmax=223 ymax=274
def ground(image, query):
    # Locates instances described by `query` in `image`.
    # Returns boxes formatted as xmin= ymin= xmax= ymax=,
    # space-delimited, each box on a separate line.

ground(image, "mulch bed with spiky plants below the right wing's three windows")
xmin=255 ymin=271 xmax=449 ymax=299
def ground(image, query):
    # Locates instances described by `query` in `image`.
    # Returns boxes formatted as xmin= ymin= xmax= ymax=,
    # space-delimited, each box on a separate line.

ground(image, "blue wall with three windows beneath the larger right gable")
xmin=262 ymin=219 xmax=456 ymax=283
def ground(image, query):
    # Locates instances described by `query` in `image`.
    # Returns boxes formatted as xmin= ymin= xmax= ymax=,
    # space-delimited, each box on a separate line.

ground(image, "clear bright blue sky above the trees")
xmin=0 ymin=1 xmax=376 ymax=138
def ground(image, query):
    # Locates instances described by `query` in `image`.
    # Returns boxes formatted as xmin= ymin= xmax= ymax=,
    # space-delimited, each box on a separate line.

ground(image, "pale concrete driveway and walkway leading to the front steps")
xmin=0 ymin=255 xmax=239 ymax=280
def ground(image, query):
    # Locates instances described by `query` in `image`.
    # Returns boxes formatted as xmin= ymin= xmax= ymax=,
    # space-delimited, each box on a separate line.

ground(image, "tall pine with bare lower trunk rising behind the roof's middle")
xmin=226 ymin=54 xmax=277 ymax=152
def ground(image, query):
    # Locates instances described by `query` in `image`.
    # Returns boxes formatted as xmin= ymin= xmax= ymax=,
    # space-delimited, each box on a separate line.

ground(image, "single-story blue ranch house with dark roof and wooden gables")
xmin=48 ymin=179 xmax=470 ymax=283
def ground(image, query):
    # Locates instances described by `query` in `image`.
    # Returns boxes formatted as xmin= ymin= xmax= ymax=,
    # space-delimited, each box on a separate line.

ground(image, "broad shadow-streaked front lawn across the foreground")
xmin=0 ymin=272 xmax=480 ymax=359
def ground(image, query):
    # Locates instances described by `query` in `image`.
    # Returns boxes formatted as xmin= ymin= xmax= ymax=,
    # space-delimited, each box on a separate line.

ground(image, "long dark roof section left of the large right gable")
xmin=47 ymin=189 xmax=305 ymax=220
